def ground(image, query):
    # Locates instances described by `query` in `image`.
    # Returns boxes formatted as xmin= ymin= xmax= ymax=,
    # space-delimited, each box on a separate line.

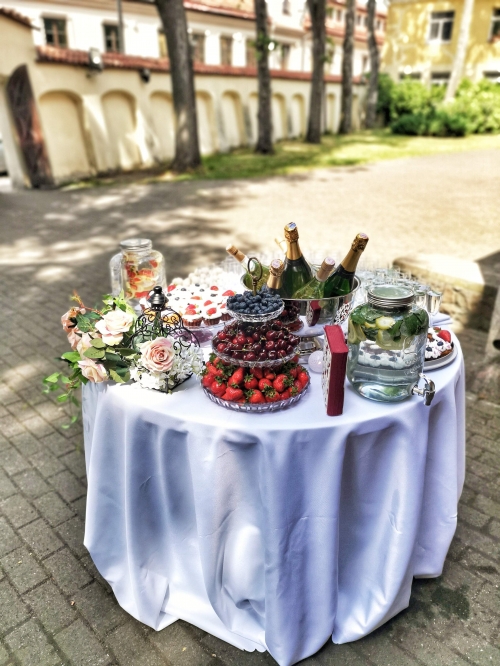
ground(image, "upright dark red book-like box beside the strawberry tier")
xmin=322 ymin=326 xmax=349 ymax=416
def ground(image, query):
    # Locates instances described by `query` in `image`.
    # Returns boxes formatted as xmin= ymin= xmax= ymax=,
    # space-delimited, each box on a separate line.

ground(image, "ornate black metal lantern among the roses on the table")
xmin=130 ymin=286 xmax=200 ymax=388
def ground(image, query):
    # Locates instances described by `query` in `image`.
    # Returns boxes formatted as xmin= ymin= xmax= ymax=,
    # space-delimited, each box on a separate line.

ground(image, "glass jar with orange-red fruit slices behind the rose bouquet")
xmin=110 ymin=238 xmax=167 ymax=309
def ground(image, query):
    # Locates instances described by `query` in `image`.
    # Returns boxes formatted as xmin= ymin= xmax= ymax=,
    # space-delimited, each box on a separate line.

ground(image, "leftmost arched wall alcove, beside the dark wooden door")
xmin=38 ymin=90 xmax=92 ymax=180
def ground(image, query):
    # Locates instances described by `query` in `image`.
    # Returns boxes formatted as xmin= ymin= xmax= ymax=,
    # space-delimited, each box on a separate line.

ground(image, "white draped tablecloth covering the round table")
xmin=83 ymin=341 xmax=465 ymax=666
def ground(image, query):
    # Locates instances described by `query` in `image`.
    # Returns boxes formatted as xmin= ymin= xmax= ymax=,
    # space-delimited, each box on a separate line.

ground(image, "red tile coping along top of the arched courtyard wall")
xmin=36 ymin=46 xmax=361 ymax=83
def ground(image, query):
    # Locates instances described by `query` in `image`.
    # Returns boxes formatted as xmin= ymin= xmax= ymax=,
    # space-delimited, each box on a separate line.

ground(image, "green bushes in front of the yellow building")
xmin=379 ymin=77 xmax=500 ymax=137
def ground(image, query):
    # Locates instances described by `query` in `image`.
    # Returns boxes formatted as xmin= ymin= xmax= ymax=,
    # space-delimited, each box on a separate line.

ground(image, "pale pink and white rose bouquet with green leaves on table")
xmin=43 ymin=293 xmax=203 ymax=422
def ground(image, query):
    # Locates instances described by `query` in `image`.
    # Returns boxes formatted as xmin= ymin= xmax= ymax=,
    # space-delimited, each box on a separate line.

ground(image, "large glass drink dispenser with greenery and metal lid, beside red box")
xmin=347 ymin=284 xmax=429 ymax=402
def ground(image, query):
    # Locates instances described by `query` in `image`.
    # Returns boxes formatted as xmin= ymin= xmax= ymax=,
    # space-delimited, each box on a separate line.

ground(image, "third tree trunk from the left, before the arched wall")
xmin=306 ymin=0 xmax=326 ymax=143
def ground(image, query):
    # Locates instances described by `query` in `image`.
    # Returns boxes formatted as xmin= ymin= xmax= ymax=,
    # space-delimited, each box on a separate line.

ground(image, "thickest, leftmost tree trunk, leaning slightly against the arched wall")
xmin=156 ymin=0 xmax=201 ymax=172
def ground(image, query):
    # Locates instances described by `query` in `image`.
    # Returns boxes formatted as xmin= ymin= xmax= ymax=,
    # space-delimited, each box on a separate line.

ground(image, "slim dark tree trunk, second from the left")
xmin=254 ymin=0 xmax=273 ymax=155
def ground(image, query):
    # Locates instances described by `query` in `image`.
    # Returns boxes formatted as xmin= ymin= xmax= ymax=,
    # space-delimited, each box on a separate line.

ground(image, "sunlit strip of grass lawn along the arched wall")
xmin=62 ymin=130 xmax=500 ymax=189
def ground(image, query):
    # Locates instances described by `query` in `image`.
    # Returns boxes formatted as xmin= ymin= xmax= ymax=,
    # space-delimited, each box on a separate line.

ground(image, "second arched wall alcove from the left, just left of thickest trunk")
xmin=101 ymin=90 xmax=141 ymax=169
